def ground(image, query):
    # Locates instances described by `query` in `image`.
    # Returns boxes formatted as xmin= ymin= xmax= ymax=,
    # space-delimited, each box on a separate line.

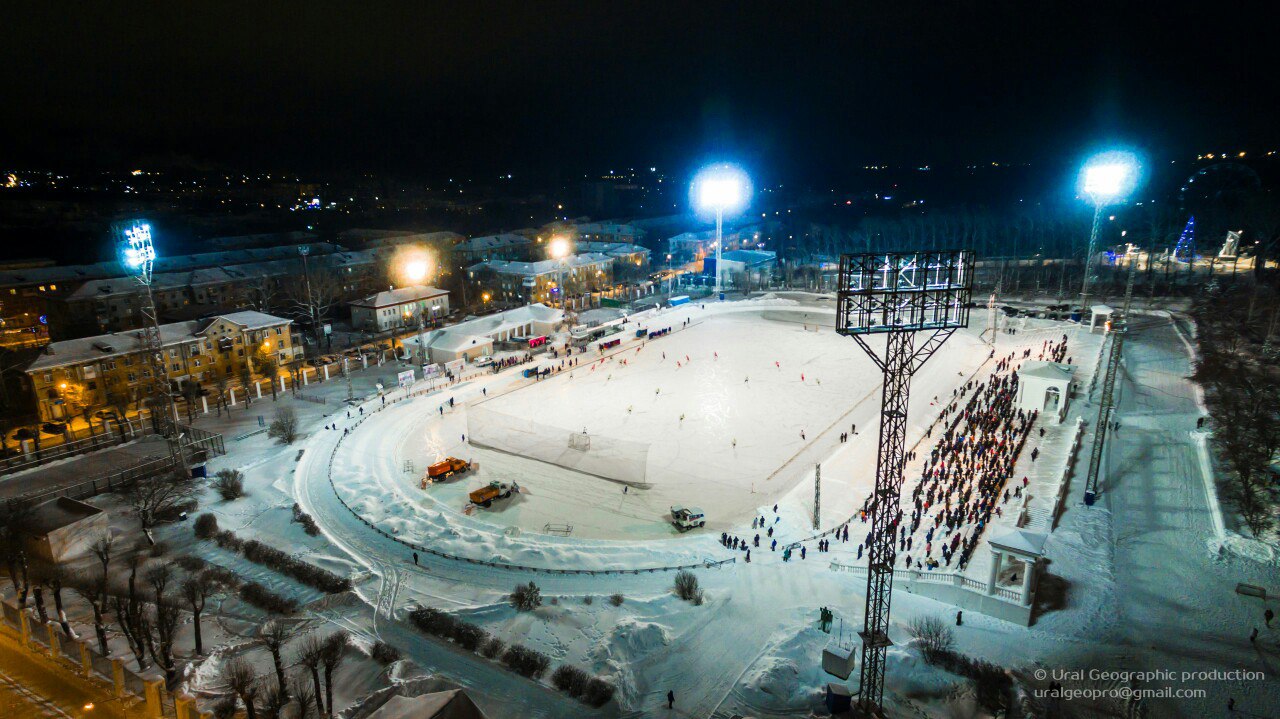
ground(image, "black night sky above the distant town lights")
xmin=0 ymin=1 xmax=1280 ymax=180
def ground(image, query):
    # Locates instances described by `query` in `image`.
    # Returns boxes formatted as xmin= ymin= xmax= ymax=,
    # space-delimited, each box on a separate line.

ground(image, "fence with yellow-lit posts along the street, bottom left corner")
xmin=0 ymin=600 xmax=183 ymax=718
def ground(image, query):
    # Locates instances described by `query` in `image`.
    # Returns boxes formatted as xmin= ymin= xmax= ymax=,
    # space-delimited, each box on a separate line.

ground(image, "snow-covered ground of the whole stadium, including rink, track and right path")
xmin=17 ymin=292 xmax=1280 ymax=718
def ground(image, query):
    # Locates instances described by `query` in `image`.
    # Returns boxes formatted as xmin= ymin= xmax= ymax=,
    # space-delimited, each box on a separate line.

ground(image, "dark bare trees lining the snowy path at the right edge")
xmin=1193 ymin=283 xmax=1280 ymax=535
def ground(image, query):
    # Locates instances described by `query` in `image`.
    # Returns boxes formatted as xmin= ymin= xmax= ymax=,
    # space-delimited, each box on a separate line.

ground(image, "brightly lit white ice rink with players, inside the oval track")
xmin=335 ymin=301 xmax=1008 ymax=540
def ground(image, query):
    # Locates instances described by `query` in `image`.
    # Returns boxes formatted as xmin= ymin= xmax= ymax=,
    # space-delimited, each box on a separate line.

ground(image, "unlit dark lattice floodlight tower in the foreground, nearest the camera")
xmin=836 ymin=249 xmax=973 ymax=715
